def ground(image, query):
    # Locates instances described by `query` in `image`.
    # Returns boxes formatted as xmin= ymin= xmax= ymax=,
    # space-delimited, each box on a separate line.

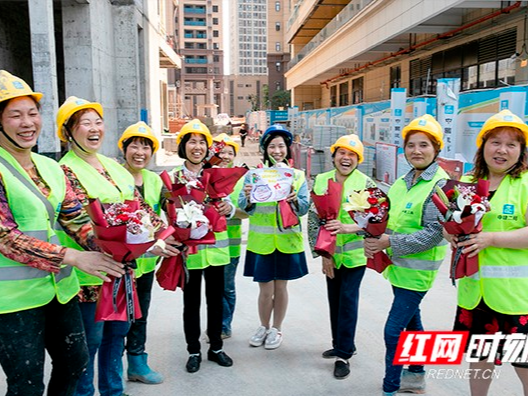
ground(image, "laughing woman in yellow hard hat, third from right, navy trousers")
xmin=308 ymin=135 xmax=376 ymax=379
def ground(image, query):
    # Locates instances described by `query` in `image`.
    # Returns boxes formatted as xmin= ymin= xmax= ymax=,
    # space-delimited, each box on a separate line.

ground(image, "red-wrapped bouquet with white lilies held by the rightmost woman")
xmin=432 ymin=179 xmax=490 ymax=285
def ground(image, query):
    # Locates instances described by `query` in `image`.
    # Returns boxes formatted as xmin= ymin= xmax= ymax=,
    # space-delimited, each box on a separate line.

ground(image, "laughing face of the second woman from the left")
xmin=71 ymin=109 xmax=104 ymax=153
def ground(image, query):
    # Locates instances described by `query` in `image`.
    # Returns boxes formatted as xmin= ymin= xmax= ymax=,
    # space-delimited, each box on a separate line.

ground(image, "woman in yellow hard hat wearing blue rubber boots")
xmin=117 ymin=121 xmax=163 ymax=384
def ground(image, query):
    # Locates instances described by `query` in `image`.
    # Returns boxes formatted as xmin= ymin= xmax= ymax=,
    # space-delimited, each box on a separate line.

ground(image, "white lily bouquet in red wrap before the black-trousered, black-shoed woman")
xmin=156 ymin=172 xmax=216 ymax=291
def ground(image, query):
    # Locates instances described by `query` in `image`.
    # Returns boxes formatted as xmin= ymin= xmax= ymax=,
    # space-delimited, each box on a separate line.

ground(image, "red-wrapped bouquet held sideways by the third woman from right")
xmin=310 ymin=179 xmax=343 ymax=258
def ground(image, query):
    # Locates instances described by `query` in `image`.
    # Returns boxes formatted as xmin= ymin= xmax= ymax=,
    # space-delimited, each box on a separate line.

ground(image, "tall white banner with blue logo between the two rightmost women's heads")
xmin=436 ymin=78 xmax=460 ymax=158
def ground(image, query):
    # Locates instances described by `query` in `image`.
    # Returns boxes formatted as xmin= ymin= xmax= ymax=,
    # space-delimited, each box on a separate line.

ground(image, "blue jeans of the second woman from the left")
xmin=75 ymin=302 xmax=130 ymax=396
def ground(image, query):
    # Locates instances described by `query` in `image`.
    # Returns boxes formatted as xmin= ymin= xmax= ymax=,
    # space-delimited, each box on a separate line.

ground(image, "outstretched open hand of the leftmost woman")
xmin=63 ymin=248 xmax=125 ymax=282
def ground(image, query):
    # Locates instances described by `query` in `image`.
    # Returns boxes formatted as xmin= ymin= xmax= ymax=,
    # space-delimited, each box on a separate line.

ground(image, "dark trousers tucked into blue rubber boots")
xmin=126 ymin=271 xmax=154 ymax=355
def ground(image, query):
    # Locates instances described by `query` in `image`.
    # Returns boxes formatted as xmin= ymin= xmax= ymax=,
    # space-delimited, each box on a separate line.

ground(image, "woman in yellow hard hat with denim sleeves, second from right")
xmin=365 ymin=114 xmax=449 ymax=396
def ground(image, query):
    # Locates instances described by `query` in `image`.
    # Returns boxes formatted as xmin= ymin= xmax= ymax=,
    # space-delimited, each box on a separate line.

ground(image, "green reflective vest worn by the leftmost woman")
xmin=0 ymin=148 xmax=79 ymax=314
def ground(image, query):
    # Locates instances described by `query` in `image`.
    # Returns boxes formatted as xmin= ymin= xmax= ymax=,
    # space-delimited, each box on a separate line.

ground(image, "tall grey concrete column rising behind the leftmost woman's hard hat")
xmin=28 ymin=0 xmax=60 ymax=158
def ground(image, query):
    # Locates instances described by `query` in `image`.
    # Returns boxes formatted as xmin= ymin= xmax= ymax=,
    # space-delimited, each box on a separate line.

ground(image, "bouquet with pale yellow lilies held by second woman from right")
xmin=343 ymin=187 xmax=392 ymax=274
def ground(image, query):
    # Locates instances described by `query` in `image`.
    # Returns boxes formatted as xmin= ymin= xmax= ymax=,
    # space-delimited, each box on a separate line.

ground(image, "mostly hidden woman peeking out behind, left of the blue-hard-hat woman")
xmin=213 ymin=133 xmax=248 ymax=338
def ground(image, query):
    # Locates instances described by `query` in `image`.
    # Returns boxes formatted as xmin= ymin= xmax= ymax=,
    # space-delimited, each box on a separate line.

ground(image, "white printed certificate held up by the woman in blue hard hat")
xmin=248 ymin=167 xmax=294 ymax=203
